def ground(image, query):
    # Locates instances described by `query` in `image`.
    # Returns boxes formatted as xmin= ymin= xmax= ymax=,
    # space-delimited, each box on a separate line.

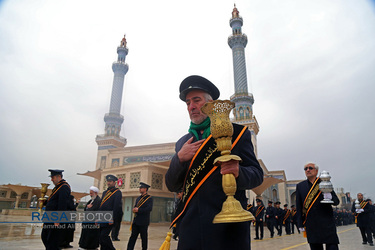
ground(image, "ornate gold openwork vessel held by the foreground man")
xmin=201 ymin=100 xmax=255 ymax=223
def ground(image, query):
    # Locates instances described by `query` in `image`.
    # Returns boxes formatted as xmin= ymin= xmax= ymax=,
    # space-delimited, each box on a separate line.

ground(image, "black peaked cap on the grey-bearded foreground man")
xmin=180 ymin=75 xmax=220 ymax=101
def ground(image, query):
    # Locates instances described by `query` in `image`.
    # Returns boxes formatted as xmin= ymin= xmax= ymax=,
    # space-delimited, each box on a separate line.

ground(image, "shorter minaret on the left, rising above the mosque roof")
xmin=96 ymin=36 xmax=129 ymax=150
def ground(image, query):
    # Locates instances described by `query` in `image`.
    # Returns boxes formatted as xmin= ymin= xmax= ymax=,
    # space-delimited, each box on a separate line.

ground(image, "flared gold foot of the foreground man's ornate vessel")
xmin=212 ymin=196 xmax=255 ymax=224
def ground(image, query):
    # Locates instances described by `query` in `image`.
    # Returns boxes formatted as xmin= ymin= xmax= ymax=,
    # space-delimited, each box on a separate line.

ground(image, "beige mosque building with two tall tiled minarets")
xmin=79 ymin=6 xmax=350 ymax=222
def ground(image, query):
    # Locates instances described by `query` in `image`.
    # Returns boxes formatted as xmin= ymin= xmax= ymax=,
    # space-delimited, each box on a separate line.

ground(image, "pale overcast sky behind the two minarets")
xmin=0 ymin=0 xmax=375 ymax=199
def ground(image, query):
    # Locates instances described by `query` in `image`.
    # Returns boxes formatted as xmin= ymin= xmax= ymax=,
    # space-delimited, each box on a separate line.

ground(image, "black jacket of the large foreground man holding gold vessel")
xmin=165 ymin=124 xmax=263 ymax=250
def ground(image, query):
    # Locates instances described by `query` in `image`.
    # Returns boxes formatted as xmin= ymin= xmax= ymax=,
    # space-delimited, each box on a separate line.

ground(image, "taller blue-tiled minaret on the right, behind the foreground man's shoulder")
xmin=228 ymin=5 xmax=259 ymax=155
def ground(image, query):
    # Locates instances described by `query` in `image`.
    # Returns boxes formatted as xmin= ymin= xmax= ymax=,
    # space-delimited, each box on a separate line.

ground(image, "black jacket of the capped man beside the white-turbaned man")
xmin=99 ymin=187 xmax=122 ymax=227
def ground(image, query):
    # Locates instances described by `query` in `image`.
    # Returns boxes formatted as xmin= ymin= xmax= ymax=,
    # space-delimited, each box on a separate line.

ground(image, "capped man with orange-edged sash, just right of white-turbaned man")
xmin=99 ymin=174 xmax=122 ymax=250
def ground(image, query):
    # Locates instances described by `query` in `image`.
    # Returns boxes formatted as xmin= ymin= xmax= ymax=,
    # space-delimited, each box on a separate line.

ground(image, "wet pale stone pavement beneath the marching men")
xmin=0 ymin=215 xmax=375 ymax=250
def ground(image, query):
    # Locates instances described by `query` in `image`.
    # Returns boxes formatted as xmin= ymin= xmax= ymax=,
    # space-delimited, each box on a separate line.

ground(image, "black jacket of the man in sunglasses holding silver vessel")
xmin=296 ymin=180 xmax=340 ymax=244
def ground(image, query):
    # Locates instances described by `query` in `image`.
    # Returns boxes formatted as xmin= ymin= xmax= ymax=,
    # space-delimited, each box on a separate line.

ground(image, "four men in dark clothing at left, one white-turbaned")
xmin=41 ymin=169 xmax=153 ymax=250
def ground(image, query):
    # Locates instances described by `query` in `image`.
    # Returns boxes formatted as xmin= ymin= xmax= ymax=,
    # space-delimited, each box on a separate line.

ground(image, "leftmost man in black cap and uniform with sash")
xmin=41 ymin=169 xmax=71 ymax=250
